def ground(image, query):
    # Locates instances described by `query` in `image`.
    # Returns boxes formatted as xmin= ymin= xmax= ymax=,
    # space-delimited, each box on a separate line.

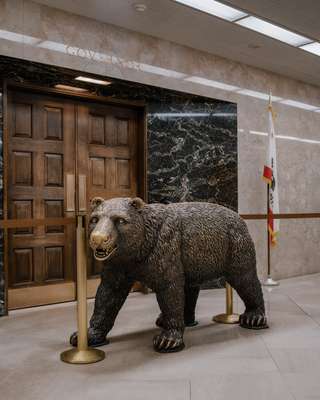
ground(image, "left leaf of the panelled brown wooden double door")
xmin=8 ymin=92 xmax=75 ymax=300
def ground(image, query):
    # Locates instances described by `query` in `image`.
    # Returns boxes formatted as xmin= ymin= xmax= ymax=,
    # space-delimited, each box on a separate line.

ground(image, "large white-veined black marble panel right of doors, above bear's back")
xmin=148 ymin=99 xmax=237 ymax=209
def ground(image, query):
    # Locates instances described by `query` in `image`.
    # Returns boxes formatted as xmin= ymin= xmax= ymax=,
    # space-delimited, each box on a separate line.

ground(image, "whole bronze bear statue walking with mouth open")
xmin=70 ymin=198 xmax=267 ymax=353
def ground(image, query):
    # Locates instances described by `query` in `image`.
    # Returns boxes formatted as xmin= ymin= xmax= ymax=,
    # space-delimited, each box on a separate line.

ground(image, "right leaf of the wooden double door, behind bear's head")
xmin=78 ymin=104 xmax=139 ymax=277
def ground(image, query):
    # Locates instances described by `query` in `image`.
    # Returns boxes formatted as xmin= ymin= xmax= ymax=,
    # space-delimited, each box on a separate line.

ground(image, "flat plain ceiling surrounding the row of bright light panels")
xmin=33 ymin=0 xmax=320 ymax=86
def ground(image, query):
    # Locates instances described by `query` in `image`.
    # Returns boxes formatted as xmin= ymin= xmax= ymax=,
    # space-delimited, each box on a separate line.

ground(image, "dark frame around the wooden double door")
xmin=1 ymin=80 xmax=148 ymax=315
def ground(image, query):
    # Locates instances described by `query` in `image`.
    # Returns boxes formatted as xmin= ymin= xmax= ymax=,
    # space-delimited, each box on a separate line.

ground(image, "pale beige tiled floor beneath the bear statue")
xmin=0 ymin=274 xmax=320 ymax=400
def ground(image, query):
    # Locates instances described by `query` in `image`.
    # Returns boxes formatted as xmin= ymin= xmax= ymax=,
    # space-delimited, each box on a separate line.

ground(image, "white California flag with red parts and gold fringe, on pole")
xmin=263 ymin=95 xmax=280 ymax=245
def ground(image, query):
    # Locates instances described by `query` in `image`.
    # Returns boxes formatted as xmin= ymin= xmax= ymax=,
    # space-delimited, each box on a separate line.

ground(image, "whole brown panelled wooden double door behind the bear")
xmin=6 ymin=91 xmax=144 ymax=309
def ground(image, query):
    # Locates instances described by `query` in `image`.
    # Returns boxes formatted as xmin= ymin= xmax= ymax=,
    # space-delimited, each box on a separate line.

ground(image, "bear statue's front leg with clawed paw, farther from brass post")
xmin=153 ymin=283 xmax=184 ymax=353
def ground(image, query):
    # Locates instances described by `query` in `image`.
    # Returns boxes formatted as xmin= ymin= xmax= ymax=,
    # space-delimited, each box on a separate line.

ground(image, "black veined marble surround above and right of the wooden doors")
xmin=0 ymin=56 xmax=238 ymax=313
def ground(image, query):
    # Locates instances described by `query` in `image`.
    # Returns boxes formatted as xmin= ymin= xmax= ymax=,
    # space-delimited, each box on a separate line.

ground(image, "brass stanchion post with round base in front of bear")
xmin=60 ymin=215 xmax=105 ymax=364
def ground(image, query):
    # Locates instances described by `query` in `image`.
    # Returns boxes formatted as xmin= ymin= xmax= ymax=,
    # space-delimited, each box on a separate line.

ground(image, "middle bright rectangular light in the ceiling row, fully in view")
xmin=236 ymin=16 xmax=310 ymax=47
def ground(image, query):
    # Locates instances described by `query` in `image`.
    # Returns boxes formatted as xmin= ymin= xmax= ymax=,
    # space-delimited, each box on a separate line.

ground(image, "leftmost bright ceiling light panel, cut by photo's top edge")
xmin=175 ymin=0 xmax=248 ymax=21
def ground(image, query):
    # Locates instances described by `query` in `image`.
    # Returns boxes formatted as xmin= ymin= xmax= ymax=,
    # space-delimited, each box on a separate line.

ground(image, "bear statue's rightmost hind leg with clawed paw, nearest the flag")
xmin=227 ymin=268 xmax=268 ymax=329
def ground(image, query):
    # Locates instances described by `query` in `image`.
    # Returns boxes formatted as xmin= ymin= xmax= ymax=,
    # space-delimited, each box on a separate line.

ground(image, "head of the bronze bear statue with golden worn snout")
xmin=89 ymin=197 xmax=146 ymax=261
